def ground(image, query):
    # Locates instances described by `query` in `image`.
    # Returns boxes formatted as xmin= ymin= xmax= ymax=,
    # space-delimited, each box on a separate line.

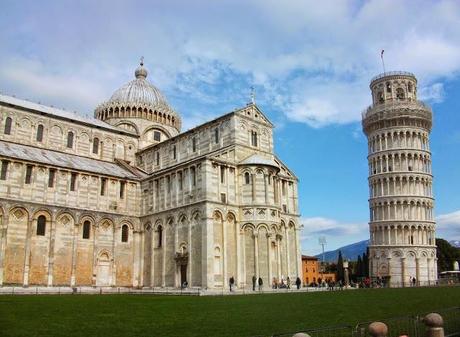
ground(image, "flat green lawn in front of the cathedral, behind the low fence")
xmin=0 ymin=287 xmax=460 ymax=337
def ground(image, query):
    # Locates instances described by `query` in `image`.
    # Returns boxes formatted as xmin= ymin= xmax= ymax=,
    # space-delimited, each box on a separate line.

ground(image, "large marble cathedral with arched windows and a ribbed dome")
xmin=0 ymin=63 xmax=301 ymax=289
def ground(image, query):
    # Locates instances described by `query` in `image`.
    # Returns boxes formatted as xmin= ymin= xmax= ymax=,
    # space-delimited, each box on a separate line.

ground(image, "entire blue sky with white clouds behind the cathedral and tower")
xmin=0 ymin=0 xmax=460 ymax=254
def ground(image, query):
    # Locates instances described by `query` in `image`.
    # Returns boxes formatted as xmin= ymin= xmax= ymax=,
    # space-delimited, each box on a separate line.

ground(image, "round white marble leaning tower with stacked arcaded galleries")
xmin=362 ymin=72 xmax=437 ymax=286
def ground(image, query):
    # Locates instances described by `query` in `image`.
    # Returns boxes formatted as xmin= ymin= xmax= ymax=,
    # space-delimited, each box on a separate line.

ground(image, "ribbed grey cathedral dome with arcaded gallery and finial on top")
xmin=95 ymin=62 xmax=181 ymax=132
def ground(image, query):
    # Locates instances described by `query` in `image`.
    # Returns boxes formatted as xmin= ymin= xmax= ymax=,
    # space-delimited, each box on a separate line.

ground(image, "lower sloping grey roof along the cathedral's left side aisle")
xmin=0 ymin=141 xmax=138 ymax=180
